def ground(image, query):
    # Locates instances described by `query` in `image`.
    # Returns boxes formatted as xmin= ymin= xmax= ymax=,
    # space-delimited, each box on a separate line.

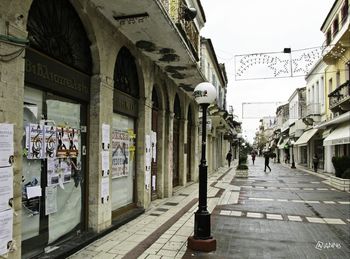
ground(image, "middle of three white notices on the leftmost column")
xmin=0 ymin=167 xmax=13 ymax=211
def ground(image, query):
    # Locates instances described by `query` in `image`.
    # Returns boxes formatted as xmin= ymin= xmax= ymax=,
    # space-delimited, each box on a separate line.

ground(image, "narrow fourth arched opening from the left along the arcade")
xmin=173 ymin=94 xmax=181 ymax=187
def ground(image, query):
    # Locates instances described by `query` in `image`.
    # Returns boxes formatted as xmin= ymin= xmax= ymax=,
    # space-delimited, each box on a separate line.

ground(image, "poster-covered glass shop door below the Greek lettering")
xmin=22 ymin=87 xmax=86 ymax=258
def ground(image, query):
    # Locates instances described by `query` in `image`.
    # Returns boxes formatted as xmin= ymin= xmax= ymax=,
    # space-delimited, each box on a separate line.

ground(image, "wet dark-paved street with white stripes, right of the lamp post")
xmin=200 ymin=157 xmax=350 ymax=258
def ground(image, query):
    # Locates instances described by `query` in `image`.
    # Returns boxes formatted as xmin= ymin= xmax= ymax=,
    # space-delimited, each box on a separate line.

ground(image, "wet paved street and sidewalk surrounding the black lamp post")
xmin=71 ymin=157 xmax=350 ymax=259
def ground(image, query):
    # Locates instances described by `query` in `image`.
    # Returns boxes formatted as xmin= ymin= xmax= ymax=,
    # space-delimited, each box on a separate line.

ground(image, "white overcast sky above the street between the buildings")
xmin=201 ymin=0 xmax=334 ymax=142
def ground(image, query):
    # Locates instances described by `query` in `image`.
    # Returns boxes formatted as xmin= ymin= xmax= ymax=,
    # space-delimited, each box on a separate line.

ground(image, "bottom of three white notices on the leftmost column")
xmin=0 ymin=209 xmax=13 ymax=255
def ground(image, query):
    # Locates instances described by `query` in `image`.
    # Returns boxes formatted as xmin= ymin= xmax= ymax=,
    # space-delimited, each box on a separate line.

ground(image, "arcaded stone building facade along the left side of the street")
xmin=0 ymin=0 xmax=232 ymax=258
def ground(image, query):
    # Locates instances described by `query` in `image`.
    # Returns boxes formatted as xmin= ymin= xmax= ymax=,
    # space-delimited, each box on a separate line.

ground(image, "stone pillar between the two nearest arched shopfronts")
xmin=88 ymin=74 xmax=113 ymax=232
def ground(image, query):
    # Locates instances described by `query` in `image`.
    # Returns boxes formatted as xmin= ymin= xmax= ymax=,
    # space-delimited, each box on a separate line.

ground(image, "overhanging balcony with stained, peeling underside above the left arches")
xmin=89 ymin=0 xmax=205 ymax=92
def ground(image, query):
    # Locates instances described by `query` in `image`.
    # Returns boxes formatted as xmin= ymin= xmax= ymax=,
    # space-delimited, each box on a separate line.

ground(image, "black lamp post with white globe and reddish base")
xmin=187 ymin=82 xmax=216 ymax=252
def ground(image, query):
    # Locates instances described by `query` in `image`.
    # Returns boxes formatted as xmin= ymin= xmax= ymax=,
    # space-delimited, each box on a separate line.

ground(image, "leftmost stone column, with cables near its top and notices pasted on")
xmin=0 ymin=18 xmax=27 ymax=258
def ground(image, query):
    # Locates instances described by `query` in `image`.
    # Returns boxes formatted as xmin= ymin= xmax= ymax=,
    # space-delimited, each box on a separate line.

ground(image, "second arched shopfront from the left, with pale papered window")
xmin=111 ymin=47 xmax=140 ymax=218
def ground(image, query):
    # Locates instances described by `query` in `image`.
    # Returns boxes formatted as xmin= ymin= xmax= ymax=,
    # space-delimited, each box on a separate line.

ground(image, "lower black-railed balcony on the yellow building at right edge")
xmin=328 ymin=80 xmax=350 ymax=113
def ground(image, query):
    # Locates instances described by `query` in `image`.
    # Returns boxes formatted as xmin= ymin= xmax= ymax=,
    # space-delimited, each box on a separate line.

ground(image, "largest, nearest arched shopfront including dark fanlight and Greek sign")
xmin=21 ymin=0 xmax=92 ymax=258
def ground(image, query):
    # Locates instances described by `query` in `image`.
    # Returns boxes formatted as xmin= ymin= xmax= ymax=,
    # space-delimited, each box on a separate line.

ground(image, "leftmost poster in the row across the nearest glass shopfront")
xmin=28 ymin=124 xmax=45 ymax=159
